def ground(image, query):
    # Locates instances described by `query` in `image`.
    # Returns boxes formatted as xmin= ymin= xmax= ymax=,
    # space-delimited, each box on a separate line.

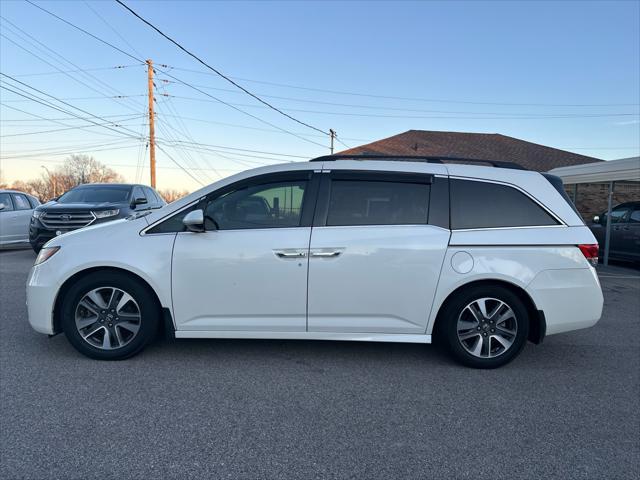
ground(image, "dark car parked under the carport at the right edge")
xmin=589 ymin=202 xmax=640 ymax=262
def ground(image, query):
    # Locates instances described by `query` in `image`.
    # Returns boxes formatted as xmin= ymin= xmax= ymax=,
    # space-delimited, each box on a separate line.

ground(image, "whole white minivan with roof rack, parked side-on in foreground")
xmin=27 ymin=156 xmax=603 ymax=368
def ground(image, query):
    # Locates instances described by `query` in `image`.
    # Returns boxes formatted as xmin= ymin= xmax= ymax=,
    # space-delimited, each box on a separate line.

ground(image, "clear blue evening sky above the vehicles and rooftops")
xmin=0 ymin=0 xmax=640 ymax=190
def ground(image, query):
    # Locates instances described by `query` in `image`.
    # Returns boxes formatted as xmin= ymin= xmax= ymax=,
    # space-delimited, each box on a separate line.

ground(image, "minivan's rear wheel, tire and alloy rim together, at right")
xmin=441 ymin=286 xmax=529 ymax=368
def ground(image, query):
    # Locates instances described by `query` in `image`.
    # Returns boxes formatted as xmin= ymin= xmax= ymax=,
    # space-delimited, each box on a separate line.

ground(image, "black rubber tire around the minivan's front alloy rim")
xmin=61 ymin=271 xmax=161 ymax=360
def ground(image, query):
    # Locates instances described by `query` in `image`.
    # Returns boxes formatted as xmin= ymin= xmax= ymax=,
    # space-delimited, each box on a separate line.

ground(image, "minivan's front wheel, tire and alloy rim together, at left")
xmin=62 ymin=272 xmax=160 ymax=360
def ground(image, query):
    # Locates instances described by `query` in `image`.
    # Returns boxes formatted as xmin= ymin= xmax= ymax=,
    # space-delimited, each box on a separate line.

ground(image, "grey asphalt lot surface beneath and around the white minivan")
xmin=0 ymin=250 xmax=640 ymax=480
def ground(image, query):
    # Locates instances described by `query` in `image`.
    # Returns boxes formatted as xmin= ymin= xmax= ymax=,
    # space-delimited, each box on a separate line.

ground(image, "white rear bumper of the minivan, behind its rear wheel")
xmin=526 ymin=267 xmax=604 ymax=335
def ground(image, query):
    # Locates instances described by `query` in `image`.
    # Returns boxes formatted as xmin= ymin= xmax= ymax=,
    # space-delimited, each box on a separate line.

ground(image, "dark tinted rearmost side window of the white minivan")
xmin=450 ymin=179 xmax=558 ymax=229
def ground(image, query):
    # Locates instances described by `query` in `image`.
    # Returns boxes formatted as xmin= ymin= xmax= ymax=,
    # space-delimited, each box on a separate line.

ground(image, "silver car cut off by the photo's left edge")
xmin=0 ymin=190 xmax=40 ymax=247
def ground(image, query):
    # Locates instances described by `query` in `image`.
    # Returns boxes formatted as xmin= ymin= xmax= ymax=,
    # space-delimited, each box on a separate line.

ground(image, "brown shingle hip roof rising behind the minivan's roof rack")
xmin=339 ymin=130 xmax=601 ymax=172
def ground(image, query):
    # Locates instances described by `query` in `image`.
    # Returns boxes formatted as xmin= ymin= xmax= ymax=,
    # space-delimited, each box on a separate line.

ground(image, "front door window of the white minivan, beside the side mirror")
xmin=204 ymin=181 xmax=307 ymax=230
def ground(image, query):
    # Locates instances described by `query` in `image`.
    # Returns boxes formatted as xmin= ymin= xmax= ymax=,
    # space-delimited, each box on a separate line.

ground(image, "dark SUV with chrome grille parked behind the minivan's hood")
xmin=29 ymin=183 xmax=166 ymax=252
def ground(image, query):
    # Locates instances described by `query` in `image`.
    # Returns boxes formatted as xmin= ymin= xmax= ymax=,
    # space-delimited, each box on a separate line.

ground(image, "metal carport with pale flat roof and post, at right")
xmin=549 ymin=157 xmax=640 ymax=265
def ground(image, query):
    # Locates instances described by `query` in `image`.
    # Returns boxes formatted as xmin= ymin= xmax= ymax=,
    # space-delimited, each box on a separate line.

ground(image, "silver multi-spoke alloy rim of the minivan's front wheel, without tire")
xmin=75 ymin=287 xmax=142 ymax=350
